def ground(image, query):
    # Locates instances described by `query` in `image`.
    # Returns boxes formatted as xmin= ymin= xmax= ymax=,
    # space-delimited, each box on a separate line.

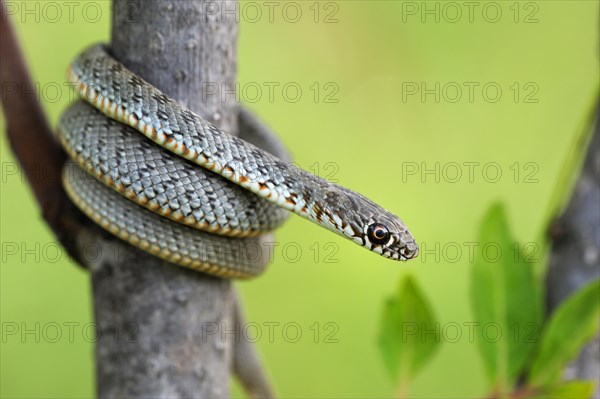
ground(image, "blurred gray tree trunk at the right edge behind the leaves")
xmin=546 ymin=115 xmax=600 ymax=398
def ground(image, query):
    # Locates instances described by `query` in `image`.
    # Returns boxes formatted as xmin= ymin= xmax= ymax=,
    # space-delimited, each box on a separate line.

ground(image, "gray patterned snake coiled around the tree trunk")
xmin=56 ymin=44 xmax=418 ymax=279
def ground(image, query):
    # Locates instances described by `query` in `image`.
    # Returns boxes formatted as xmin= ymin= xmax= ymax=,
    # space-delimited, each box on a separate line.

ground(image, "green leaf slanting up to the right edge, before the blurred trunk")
xmin=529 ymin=279 xmax=600 ymax=387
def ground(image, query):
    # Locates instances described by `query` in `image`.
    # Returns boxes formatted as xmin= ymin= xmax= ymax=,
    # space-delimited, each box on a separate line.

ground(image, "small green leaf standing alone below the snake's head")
xmin=379 ymin=276 xmax=441 ymax=385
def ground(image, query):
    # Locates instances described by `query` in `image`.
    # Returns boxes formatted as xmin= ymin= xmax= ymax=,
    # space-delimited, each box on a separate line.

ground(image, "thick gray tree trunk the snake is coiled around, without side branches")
xmin=89 ymin=0 xmax=237 ymax=398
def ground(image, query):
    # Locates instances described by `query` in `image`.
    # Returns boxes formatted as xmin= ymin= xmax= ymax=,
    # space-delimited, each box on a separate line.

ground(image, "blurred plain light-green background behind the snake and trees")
xmin=0 ymin=1 xmax=599 ymax=398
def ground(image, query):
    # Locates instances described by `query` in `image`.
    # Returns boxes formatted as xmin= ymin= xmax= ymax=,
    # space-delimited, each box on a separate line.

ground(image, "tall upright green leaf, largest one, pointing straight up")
xmin=471 ymin=204 xmax=542 ymax=392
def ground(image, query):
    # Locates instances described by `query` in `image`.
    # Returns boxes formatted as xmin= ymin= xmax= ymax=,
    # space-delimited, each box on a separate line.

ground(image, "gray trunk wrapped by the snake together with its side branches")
xmin=0 ymin=0 xmax=273 ymax=398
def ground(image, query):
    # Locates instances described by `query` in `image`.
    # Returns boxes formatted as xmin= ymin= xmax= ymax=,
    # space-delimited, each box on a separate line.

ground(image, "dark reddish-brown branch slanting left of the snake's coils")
xmin=0 ymin=1 xmax=85 ymax=259
